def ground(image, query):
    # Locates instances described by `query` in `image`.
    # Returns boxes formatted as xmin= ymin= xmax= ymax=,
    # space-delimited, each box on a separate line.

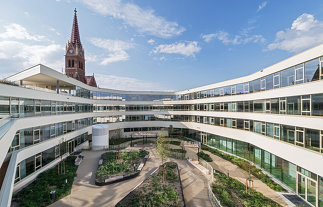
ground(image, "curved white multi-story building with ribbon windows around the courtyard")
xmin=0 ymin=8 xmax=323 ymax=207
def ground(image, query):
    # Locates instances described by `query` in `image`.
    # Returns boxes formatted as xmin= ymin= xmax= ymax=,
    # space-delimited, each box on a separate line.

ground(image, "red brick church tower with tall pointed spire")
xmin=65 ymin=9 xmax=97 ymax=87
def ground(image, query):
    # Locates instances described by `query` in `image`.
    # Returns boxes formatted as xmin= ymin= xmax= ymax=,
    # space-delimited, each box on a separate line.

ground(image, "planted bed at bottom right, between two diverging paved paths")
xmin=212 ymin=171 xmax=280 ymax=207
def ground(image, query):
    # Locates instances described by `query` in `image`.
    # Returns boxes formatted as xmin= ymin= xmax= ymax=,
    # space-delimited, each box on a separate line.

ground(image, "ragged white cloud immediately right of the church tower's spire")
xmin=90 ymin=38 xmax=134 ymax=65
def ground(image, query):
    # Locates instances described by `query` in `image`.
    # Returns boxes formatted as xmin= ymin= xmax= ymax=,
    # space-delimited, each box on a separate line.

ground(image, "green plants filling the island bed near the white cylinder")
xmin=96 ymin=150 xmax=148 ymax=183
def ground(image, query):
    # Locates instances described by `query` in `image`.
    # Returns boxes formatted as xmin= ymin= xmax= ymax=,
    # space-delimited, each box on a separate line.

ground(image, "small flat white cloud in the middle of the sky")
xmin=153 ymin=41 xmax=201 ymax=56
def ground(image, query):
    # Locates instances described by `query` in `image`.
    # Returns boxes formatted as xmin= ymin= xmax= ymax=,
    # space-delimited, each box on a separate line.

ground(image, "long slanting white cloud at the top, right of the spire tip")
xmin=80 ymin=0 xmax=185 ymax=38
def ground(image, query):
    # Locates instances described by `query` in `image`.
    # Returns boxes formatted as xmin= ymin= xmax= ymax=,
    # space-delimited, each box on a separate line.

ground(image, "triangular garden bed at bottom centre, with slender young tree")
xmin=116 ymin=162 xmax=185 ymax=207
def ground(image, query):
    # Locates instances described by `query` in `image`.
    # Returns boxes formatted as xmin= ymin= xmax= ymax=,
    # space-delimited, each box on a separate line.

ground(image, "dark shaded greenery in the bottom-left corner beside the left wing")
xmin=12 ymin=156 xmax=77 ymax=207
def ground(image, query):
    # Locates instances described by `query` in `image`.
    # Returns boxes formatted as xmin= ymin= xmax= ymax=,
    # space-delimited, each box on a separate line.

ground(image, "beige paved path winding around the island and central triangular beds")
xmin=51 ymin=148 xmax=211 ymax=207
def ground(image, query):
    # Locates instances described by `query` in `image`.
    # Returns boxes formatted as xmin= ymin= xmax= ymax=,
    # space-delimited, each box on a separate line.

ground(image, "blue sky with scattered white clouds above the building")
xmin=0 ymin=0 xmax=323 ymax=91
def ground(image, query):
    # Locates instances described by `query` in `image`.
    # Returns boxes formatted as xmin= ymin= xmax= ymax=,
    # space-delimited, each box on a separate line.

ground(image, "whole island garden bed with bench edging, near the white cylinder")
xmin=95 ymin=150 xmax=149 ymax=186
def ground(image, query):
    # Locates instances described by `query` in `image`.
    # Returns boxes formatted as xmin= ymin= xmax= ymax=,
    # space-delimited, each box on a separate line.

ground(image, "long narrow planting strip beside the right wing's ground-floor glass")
xmin=202 ymin=145 xmax=286 ymax=192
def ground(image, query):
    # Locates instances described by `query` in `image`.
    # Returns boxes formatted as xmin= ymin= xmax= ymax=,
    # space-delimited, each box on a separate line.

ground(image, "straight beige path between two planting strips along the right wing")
xmin=189 ymin=148 xmax=288 ymax=206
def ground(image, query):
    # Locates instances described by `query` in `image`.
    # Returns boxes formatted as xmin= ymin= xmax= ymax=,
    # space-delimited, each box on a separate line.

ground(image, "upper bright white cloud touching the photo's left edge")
xmin=0 ymin=23 xmax=45 ymax=41
